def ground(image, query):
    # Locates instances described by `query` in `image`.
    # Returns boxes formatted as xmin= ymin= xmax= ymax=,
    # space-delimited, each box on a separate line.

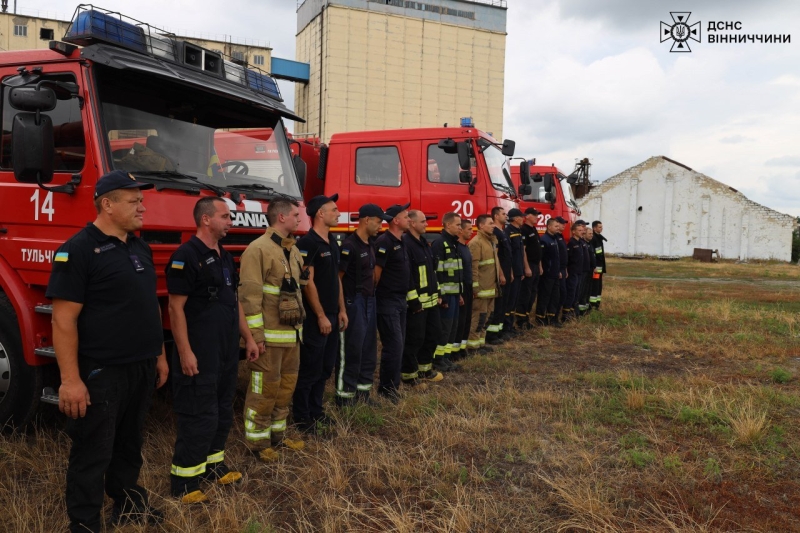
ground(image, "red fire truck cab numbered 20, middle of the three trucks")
xmin=303 ymin=122 xmax=518 ymax=233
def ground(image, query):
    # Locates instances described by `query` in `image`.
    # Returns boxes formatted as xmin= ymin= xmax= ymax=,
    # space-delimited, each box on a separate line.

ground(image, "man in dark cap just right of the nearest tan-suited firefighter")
xmin=292 ymin=194 xmax=347 ymax=433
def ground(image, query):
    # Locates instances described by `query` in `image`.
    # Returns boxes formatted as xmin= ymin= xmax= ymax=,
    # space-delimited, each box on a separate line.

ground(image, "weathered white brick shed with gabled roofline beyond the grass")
xmin=578 ymin=156 xmax=794 ymax=261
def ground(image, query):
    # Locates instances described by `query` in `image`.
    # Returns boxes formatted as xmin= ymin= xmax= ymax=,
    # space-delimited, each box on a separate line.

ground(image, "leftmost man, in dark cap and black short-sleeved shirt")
xmin=46 ymin=170 xmax=169 ymax=532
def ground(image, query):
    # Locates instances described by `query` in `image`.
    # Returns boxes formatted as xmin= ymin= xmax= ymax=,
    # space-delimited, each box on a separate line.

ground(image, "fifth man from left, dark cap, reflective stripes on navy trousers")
xmin=336 ymin=204 xmax=390 ymax=407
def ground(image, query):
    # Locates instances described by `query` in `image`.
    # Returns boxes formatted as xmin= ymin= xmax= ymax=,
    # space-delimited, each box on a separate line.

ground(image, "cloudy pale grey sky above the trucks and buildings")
xmin=20 ymin=0 xmax=800 ymax=216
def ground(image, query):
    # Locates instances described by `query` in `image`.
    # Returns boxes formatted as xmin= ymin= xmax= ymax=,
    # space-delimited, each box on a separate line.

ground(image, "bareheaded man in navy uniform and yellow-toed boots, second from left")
xmin=166 ymin=196 xmax=258 ymax=503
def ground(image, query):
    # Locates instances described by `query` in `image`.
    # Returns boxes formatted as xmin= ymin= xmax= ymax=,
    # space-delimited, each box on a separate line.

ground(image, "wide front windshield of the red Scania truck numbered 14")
xmin=98 ymin=69 xmax=301 ymax=199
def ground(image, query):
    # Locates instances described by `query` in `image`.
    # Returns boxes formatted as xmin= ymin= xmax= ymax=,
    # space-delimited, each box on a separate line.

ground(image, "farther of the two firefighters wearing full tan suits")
xmin=467 ymin=215 xmax=505 ymax=354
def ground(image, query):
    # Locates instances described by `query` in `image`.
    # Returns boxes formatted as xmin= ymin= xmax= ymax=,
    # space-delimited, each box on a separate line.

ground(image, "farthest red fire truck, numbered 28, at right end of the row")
xmin=511 ymin=161 xmax=580 ymax=240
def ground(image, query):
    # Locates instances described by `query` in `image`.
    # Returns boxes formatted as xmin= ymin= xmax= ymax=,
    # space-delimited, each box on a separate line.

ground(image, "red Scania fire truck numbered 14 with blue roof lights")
xmin=0 ymin=5 xmax=308 ymax=426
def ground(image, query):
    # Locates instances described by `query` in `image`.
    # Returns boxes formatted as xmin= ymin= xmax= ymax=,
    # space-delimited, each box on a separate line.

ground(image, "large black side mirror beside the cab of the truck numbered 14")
xmin=11 ymin=113 xmax=55 ymax=185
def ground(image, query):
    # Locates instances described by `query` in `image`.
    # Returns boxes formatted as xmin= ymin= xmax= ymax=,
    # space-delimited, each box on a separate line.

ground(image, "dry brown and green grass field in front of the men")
xmin=0 ymin=260 xmax=800 ymax=533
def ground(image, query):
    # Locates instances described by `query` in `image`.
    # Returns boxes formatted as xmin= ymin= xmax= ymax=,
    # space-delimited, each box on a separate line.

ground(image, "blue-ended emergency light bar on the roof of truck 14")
xmin=63 ymin=4 xmax=283 ymax=102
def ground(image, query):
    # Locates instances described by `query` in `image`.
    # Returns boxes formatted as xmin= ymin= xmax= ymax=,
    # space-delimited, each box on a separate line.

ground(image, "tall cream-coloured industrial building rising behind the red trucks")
xmin=295 ymin=0 xmax=507 ymax=141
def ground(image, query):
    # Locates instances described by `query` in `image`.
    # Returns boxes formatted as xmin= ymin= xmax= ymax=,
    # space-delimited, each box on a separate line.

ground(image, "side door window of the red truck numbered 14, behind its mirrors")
xmin=0 ymin=74 xmax=86 ymax=172
